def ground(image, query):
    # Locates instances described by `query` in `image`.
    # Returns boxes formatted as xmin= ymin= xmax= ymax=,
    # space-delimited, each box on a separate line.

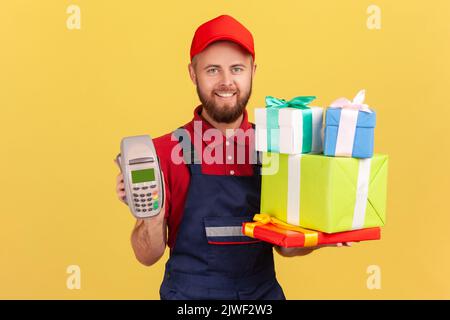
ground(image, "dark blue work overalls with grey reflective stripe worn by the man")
xmin=160 ymin=127 xmax=285 ymax=300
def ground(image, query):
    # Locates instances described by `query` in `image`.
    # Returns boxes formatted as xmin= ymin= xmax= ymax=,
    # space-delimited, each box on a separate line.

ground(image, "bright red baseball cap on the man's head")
xmin=191 ymin=15 xmax=255 ymax=61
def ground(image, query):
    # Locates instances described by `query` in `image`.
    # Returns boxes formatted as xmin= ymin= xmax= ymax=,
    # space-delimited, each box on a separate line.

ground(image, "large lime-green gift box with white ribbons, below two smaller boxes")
xmin=261 ymin=152 xmax=388 ymax=233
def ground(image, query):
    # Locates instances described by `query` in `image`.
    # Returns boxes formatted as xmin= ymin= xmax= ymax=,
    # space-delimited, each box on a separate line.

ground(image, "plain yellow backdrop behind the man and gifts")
xmin=0 ymin=0 xmax=450 ymax=299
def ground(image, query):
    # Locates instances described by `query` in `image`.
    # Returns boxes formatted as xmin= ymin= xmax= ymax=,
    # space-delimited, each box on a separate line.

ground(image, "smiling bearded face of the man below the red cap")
xmin=189 ymin=41 xmax=256 ymax=123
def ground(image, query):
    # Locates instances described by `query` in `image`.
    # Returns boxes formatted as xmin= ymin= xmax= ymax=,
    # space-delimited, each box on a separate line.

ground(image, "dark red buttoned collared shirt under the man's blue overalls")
xmin=153 ymin=105 xmax=255 ymax=250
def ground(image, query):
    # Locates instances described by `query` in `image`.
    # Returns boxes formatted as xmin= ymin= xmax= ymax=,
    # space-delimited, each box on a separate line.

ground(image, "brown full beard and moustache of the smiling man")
xmin=197 ymin=80 xmax=253 ymax=123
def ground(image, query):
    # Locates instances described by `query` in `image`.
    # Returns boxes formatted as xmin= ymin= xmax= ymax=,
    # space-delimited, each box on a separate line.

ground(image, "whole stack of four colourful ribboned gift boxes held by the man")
xmin=243 ymin=90 xmax=388 ymax=247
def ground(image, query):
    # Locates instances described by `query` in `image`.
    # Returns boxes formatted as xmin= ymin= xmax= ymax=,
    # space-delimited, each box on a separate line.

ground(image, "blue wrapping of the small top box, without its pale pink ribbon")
xmin=323 ymin=108 xmax=376 ymax=158
